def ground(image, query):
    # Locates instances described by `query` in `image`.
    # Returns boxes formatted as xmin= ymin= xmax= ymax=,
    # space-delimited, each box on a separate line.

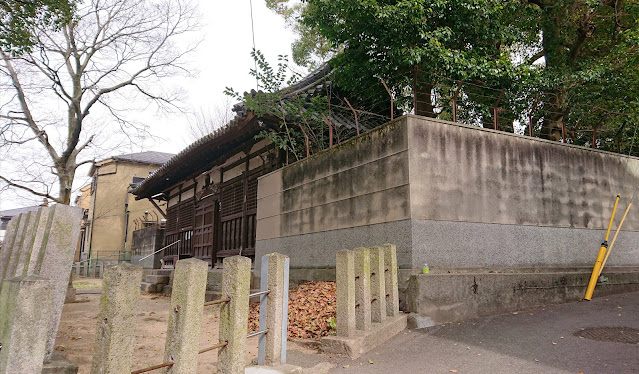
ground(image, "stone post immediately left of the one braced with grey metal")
xmin=217 ymin=256 xmax=251 ymax=374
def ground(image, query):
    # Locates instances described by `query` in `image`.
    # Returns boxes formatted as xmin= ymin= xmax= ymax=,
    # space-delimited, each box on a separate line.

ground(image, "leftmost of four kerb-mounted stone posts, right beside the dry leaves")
xmin=335 ymin=249 xmax=355 ymax=337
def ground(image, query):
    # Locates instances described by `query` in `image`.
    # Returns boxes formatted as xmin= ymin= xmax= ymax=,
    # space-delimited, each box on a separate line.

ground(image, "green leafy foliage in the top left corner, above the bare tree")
xmin=0 ymin=0 xmax=76 ymax=55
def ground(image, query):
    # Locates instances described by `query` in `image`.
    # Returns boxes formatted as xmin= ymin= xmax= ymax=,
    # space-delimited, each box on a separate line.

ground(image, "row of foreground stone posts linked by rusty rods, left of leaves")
xmin=91 ymin=254 xmax=286 ymax=374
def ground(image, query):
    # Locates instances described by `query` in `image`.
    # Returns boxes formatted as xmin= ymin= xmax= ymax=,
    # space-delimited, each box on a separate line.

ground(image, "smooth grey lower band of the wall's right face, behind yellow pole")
xmin=411 ymin=219 xmax=639 ymax=268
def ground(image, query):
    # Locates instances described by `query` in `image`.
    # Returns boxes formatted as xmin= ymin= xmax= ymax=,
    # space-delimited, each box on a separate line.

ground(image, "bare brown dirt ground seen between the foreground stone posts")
xmin=56 ymin=278 xmax=262 ymax=374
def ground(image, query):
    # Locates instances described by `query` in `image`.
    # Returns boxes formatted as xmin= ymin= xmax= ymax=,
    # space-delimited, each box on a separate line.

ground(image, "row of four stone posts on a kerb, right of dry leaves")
xmin=335 ymin=244 xmax=399 ymax=337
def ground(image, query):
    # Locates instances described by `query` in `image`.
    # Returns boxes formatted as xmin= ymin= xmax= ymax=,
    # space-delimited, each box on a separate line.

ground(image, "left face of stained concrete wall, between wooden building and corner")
xmin=256 ymin=121 xmax=410 ymax=268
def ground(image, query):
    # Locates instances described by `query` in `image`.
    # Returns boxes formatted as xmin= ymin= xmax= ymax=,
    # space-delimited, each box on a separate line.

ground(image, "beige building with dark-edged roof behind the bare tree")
xmin=81 ymin=151 xmax=173 ymax=260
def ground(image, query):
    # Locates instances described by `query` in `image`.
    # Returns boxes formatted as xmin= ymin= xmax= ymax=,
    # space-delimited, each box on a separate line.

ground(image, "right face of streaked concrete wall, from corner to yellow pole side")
xmin=406 ymin=116 xmax=639 ymax=267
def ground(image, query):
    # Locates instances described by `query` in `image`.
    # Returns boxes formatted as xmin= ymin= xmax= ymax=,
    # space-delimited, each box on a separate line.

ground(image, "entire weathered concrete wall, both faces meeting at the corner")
xmin=257 ymin=116 xmax=639 ymax=268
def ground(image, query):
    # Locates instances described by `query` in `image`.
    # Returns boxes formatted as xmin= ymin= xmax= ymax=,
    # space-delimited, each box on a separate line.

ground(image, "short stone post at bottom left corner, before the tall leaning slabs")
xmin=0 ymin=275 xmax=52 ymax=374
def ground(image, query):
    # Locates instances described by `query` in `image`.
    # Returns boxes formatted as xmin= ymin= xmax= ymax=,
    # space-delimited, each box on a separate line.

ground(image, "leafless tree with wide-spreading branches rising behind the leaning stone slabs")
xmin=0 ymin=0 xmax=199 ymax=204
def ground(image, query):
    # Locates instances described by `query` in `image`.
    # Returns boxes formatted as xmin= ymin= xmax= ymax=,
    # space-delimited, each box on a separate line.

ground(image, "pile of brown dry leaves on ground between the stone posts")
xmin=249 ymin=282 xmax=337 ymax=340
